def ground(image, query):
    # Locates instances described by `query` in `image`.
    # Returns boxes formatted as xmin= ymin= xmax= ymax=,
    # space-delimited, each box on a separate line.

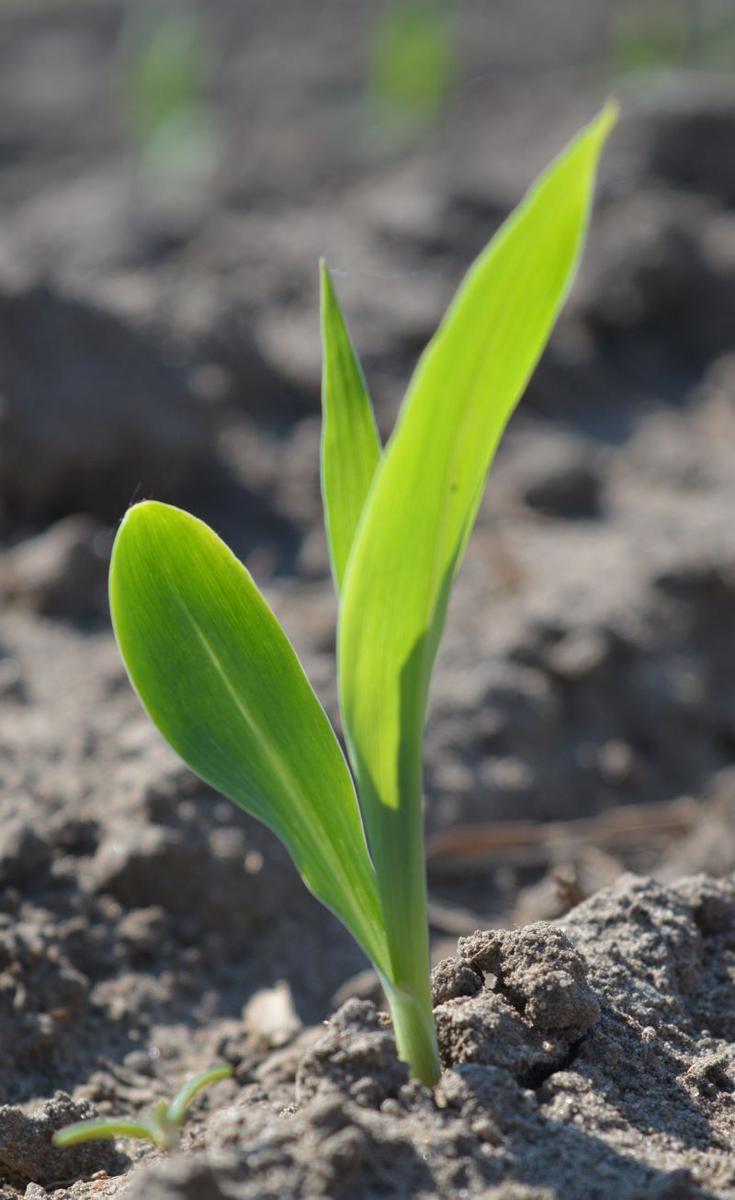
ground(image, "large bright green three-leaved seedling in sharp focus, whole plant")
xmin=109 ymin=106 xmax=615 ymax=1085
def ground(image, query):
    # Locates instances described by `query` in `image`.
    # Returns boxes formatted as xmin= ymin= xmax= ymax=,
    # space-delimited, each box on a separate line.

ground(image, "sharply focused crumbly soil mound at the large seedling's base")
xmin=117 ymin=875 xmax=735 ymax=1200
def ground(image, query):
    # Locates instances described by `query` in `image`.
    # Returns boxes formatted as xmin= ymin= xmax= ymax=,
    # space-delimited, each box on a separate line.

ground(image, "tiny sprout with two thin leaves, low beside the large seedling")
xmin=53 ymin=1066 xmax=232 ymax=1150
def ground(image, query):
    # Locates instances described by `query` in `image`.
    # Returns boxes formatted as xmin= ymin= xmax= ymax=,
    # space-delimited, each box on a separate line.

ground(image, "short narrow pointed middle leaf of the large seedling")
xmin=321 ymin=262 xmax=381 ymax=592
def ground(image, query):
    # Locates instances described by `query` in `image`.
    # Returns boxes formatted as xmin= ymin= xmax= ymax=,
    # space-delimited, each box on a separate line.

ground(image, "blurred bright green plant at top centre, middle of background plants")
xmin=368 ymin=0 xmax=459 ymax=137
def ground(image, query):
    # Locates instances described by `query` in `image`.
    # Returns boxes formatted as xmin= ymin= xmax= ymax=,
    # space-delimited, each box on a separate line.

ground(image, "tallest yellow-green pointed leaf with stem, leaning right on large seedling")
xmin=339 ymin=107 xmax=615 ymax=994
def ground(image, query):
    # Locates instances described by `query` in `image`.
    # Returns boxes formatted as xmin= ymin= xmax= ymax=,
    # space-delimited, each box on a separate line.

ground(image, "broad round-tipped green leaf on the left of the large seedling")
xmin=110 ymin=502 xmax=388 ymax=971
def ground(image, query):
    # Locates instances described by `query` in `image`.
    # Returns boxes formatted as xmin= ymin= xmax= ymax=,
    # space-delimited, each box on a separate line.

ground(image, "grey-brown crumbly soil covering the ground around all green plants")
xmin=0 ymin=0 xmax=735 ymax=1200
